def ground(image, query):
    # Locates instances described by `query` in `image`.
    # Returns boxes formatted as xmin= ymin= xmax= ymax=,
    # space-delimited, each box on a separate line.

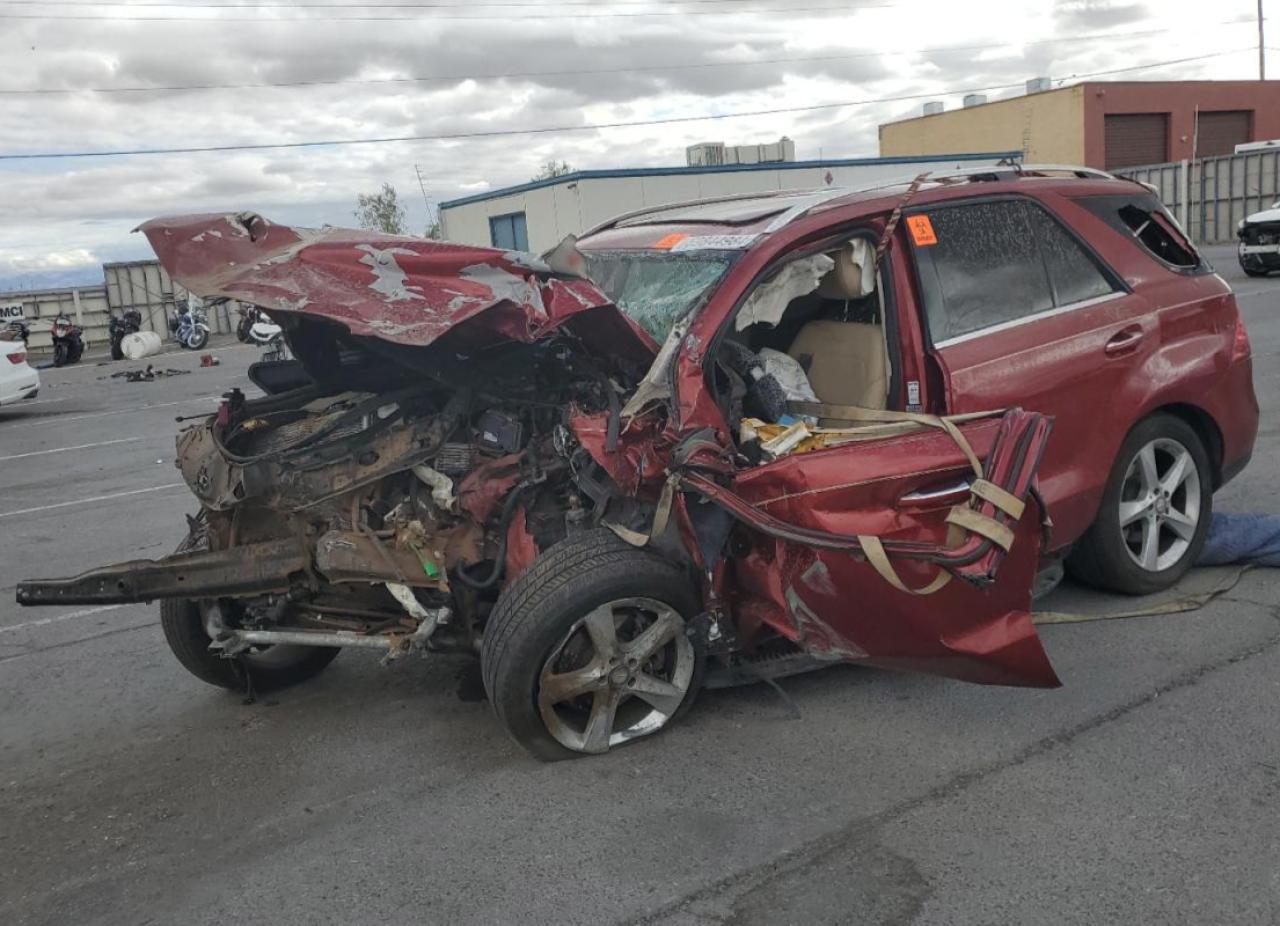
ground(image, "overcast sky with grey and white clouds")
xmin=0 ymin=0 xmax=1264 ymax=288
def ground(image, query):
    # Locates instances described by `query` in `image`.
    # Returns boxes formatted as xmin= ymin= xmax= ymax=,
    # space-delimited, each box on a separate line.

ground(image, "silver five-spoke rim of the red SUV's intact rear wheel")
xmin=1120 ymin=438 xmax=1201 ymax=573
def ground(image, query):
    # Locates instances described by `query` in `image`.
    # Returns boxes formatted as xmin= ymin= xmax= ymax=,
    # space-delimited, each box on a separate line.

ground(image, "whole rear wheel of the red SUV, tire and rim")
xmin=1066 ymin=414 xmax=1213 ymax=594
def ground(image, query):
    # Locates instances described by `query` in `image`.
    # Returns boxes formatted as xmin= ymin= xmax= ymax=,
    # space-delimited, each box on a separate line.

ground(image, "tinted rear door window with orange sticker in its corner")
xmin=909 ymin=200 xmax=1117 ymax=345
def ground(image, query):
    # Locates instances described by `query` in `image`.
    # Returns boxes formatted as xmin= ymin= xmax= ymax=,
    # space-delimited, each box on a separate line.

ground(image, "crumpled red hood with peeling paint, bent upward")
xmin=140 ymin=213 xmax=655 ymax=357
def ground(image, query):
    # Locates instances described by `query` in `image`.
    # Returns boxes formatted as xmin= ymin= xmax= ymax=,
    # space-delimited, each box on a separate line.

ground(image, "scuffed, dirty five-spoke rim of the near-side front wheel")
xmin=538 ymin=598 xmax=694 ymax=753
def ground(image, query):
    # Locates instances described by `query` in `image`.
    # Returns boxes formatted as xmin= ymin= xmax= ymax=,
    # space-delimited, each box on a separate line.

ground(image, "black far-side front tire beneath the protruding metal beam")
xmin=160 ymin=525 xmax=342 ymax=692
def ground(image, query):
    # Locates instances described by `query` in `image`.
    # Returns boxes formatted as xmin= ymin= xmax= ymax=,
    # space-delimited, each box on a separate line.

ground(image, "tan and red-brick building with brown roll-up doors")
xmin=879 ymin=78 xmax=1280 ymax=170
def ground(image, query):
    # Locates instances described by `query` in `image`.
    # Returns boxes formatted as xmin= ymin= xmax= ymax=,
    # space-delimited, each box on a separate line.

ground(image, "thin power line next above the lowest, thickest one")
xmin=0 ymin=19 xmax=1252 ymax=96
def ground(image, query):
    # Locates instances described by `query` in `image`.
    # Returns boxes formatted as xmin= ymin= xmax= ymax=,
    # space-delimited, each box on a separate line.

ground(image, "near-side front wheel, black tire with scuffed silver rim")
xmin=480 ymin=529 xmax=705 ymax=761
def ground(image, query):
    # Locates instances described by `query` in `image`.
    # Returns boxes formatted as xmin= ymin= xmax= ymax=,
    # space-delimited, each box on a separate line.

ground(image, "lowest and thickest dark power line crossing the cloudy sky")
xmin=0 ymin=45 xmax=1254 ymax=161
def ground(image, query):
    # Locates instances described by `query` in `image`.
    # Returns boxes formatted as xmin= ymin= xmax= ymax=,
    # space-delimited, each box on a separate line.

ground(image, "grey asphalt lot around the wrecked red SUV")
xmin=0 ymin=248 xmax=1280 ymax=926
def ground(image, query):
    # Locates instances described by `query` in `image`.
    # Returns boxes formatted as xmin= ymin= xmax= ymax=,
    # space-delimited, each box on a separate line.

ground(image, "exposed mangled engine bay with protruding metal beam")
xmin=22 ymin=329 xmax=650 ymax=656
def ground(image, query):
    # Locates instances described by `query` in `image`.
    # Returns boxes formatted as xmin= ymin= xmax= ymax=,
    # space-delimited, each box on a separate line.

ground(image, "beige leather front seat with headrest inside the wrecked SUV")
xmin=787 ymin=247 xmax=888 ymax=417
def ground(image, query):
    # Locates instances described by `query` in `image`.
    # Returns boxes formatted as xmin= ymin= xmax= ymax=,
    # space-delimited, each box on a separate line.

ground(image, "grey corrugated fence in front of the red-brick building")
xmin=1115 ymin=149 xmax=1280 ymax=245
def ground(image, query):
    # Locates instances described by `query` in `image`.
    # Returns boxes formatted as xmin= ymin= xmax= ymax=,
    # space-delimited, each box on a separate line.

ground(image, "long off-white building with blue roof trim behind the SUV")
xmin=440 ymin=152 xmax=1018 ymax=252
